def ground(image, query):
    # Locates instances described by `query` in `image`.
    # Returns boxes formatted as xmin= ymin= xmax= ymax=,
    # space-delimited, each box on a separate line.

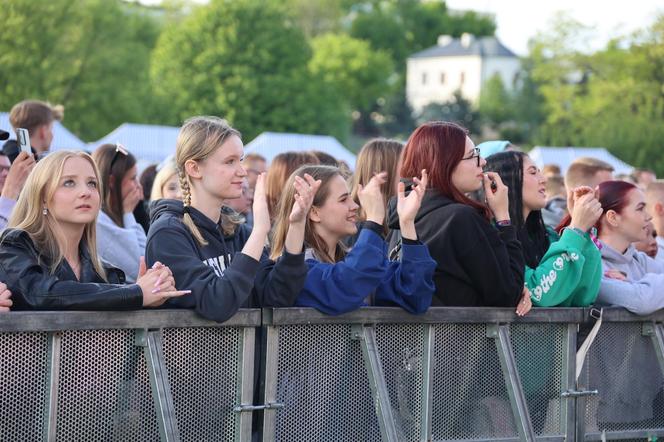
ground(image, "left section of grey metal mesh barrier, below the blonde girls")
xmin=0 ymin=310 xmax=261 ymax=441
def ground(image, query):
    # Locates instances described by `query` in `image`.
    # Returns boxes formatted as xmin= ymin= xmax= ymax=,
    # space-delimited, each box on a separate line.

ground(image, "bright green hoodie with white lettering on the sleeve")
xmin=525 ymin=228 xmax=602 ymax=307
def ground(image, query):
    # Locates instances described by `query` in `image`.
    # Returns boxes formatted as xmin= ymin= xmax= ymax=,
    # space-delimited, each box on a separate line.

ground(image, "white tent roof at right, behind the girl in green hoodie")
xmin=528 ymin=146 xmax=634 ymax=175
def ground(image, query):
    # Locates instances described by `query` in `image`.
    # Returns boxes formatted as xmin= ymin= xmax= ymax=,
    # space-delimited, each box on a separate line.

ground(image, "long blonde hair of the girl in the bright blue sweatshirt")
xmin=270 ymin=166 xmax=347 ymax=263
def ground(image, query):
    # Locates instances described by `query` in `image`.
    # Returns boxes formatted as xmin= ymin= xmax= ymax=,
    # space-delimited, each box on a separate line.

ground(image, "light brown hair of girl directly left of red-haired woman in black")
xmin=350 ymin=138 xmax=403 ymax=233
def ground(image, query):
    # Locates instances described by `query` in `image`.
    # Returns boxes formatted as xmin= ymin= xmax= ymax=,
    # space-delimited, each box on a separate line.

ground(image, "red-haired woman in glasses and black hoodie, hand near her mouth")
xmin=390 ymin=122 xmax=530 ymax=308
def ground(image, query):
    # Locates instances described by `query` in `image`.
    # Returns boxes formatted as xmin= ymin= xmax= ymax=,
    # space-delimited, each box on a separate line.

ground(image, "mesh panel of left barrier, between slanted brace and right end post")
xmin=163 ymin=327 xmax=243 ymax=442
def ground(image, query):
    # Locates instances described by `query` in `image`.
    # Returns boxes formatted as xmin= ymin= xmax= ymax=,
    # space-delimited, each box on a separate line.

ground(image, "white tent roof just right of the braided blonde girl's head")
xmin=244 ymin=132 xmax=355 ymax=168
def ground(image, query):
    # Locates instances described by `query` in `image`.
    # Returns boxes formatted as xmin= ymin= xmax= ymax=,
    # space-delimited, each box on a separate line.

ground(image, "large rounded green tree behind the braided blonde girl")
xmin=151 ymin=0 xmax=348 ymax=139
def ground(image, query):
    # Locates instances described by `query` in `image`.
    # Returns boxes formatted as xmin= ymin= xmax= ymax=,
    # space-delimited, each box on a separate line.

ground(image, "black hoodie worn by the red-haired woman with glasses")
xmin=389 ymin=189 xmax=525 ymax=307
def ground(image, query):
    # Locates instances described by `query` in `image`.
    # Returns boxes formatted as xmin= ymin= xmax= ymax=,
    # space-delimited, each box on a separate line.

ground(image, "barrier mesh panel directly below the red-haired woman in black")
xmin=432 ymin=324 xmax=518 ymax=440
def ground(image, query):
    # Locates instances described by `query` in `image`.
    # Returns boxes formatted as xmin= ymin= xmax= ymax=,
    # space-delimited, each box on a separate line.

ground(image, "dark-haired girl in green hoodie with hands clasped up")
xmin=485 ymin=151 xmax=602 ymax=307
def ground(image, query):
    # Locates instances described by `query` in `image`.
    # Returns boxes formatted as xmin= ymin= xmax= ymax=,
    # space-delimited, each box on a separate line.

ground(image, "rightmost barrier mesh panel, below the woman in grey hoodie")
xmin=582 ymin=322 xmax=664 ymax=432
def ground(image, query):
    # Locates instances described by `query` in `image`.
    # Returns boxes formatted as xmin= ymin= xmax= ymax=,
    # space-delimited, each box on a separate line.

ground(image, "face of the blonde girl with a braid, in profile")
xmin=190 ymin=135 xmax=247 ymax=200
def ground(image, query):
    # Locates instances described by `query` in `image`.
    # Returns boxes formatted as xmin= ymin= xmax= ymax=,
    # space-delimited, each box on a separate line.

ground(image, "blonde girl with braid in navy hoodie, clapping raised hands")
xmin=146 ymin=117 xmax=320 ymax=322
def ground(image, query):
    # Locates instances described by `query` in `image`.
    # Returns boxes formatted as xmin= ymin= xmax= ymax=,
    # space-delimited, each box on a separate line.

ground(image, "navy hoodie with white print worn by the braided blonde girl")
xmin=145 ymin=199 xmax=308 ymax=322
